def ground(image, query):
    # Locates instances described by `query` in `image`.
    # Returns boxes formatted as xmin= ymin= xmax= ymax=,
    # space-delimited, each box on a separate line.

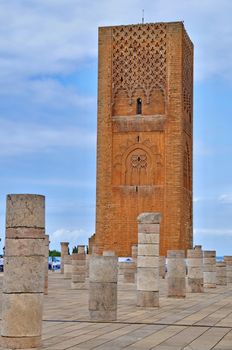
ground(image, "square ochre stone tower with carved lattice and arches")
xmin=95 ymin=22 xmax=193 ymax=256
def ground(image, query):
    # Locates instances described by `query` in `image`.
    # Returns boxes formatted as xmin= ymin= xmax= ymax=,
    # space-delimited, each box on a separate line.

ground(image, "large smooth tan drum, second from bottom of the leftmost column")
xmin=1 ymin=293 xmax=43 ymax=337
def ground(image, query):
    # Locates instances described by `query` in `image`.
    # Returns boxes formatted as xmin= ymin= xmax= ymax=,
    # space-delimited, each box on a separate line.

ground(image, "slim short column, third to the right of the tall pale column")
xmin=203 ymin=250 xmax=216 ymax=288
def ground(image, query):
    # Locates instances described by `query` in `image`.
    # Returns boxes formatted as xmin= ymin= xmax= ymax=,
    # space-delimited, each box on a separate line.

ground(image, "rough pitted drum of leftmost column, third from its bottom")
xmin=3 ymin=256 xmax=44 ymax=293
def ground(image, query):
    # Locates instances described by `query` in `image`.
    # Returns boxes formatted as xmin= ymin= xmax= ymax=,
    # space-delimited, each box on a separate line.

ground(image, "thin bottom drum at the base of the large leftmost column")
xmin=0 ymin=336 xmax=41 ymax=349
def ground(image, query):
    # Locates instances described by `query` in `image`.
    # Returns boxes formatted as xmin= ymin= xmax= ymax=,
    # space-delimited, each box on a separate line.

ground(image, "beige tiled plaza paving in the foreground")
xmin=0 ymin=272 xmax=232 ymax=350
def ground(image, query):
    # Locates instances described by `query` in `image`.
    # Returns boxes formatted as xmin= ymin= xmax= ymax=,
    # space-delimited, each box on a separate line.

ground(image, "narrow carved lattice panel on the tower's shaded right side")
xmin=183 ymin=32 xmax=193 ymax=122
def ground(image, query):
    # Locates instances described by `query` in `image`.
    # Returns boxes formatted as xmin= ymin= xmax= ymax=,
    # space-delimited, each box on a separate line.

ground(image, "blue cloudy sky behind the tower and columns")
xmin=0 ymin=0 xmax=232 ymax=255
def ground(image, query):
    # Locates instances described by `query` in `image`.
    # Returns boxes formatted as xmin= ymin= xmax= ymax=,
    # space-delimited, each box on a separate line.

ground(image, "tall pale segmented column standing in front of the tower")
xmin=137 ymin=213 xmax=161 ymax=307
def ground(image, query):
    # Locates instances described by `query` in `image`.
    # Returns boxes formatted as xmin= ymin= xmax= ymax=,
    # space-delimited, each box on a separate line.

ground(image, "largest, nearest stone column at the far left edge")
xmin=1 ymin=194 xmax=45 ymax=349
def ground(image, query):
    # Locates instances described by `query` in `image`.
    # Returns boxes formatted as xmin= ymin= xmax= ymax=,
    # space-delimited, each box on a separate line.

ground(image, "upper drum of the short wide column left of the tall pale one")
xmin=89 ymin=256 xmax=118 ymax=283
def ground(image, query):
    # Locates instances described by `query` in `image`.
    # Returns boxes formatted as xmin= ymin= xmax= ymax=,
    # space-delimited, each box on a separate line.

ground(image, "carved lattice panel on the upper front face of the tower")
xmin=112 ymin=23 xmax=167 ymax=103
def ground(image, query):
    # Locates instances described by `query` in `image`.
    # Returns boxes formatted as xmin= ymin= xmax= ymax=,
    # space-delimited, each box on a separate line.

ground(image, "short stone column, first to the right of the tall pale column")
xmin=167 ymin=250 xmax=186 ymax=298
